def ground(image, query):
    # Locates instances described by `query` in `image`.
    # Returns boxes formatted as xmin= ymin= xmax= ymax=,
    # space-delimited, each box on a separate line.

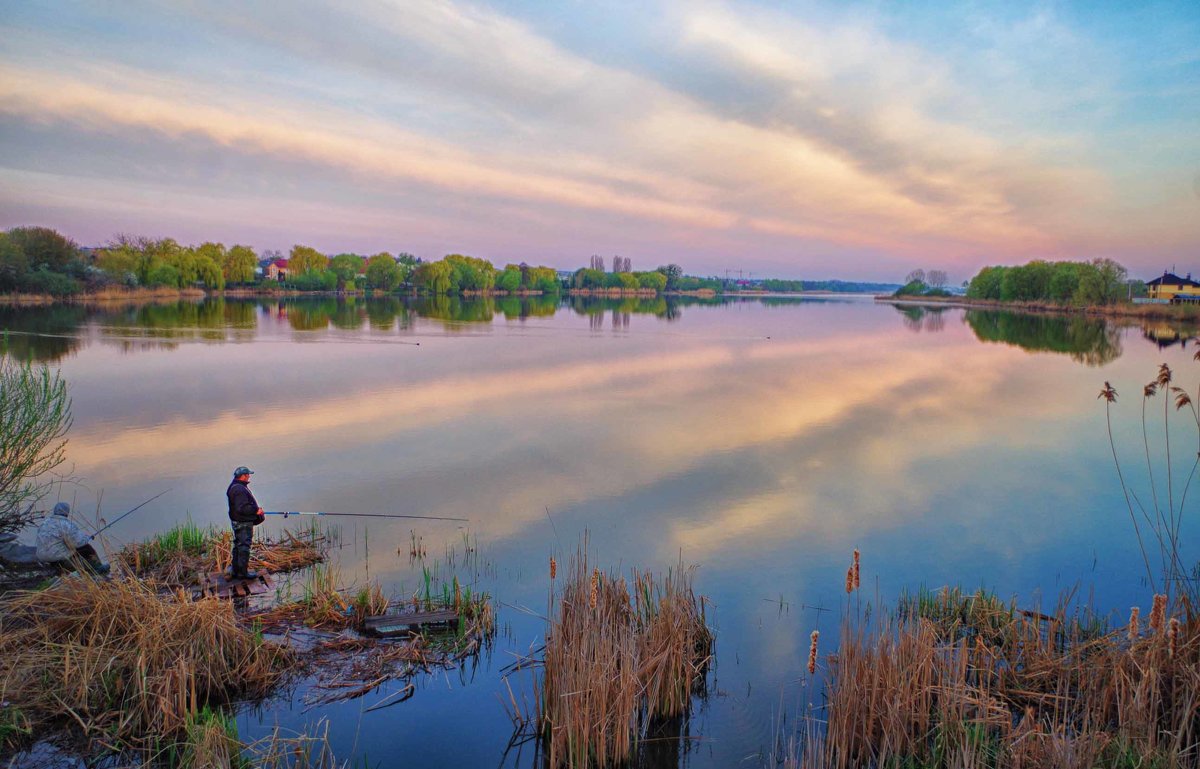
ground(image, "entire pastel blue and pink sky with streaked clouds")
xmin=0 ymin=0 xmax=1200 ymax=282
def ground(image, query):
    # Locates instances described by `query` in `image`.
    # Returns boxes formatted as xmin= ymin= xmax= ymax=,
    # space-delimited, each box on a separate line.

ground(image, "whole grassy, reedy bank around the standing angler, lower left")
xmin=0 ymin=523 xmax=496 ymax=769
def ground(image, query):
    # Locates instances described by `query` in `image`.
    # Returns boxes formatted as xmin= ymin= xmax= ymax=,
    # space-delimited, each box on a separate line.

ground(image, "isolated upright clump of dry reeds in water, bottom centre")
xmin=536 ymin=548 xmax=713 ymax=767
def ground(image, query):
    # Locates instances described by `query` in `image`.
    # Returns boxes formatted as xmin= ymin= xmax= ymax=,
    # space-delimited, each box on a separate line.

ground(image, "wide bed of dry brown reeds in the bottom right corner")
xmin=794 ymin=595 xmax=1200 ymax=769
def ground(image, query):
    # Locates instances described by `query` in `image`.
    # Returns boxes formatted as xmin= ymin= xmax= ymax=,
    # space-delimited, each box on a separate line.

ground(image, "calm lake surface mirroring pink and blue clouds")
xmin=0 ymin=298 xmax=1200 ymax=767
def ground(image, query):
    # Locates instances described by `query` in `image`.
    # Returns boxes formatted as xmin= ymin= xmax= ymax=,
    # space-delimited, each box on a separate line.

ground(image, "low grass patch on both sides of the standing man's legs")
xmin=114 ymin=521 xmax=325 ymax=587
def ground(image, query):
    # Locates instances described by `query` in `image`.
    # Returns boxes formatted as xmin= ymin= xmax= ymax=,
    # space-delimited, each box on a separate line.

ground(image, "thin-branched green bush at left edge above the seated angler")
xmin=0 ymin=355 xmax=71 ymax=534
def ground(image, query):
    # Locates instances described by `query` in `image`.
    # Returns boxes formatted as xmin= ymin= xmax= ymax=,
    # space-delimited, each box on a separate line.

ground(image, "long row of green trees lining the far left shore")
xmin=0 ymin=227 xmax=912 ymax=305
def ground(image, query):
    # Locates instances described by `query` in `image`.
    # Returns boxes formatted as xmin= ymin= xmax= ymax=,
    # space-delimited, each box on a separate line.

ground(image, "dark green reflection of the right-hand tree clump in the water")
xmin=964 ymin=310 xmax=1122 ymax=366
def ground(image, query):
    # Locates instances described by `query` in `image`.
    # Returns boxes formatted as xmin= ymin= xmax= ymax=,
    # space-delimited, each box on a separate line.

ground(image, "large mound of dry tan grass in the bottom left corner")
xmin=0 ymin=577 xmax=292 ymax=750
